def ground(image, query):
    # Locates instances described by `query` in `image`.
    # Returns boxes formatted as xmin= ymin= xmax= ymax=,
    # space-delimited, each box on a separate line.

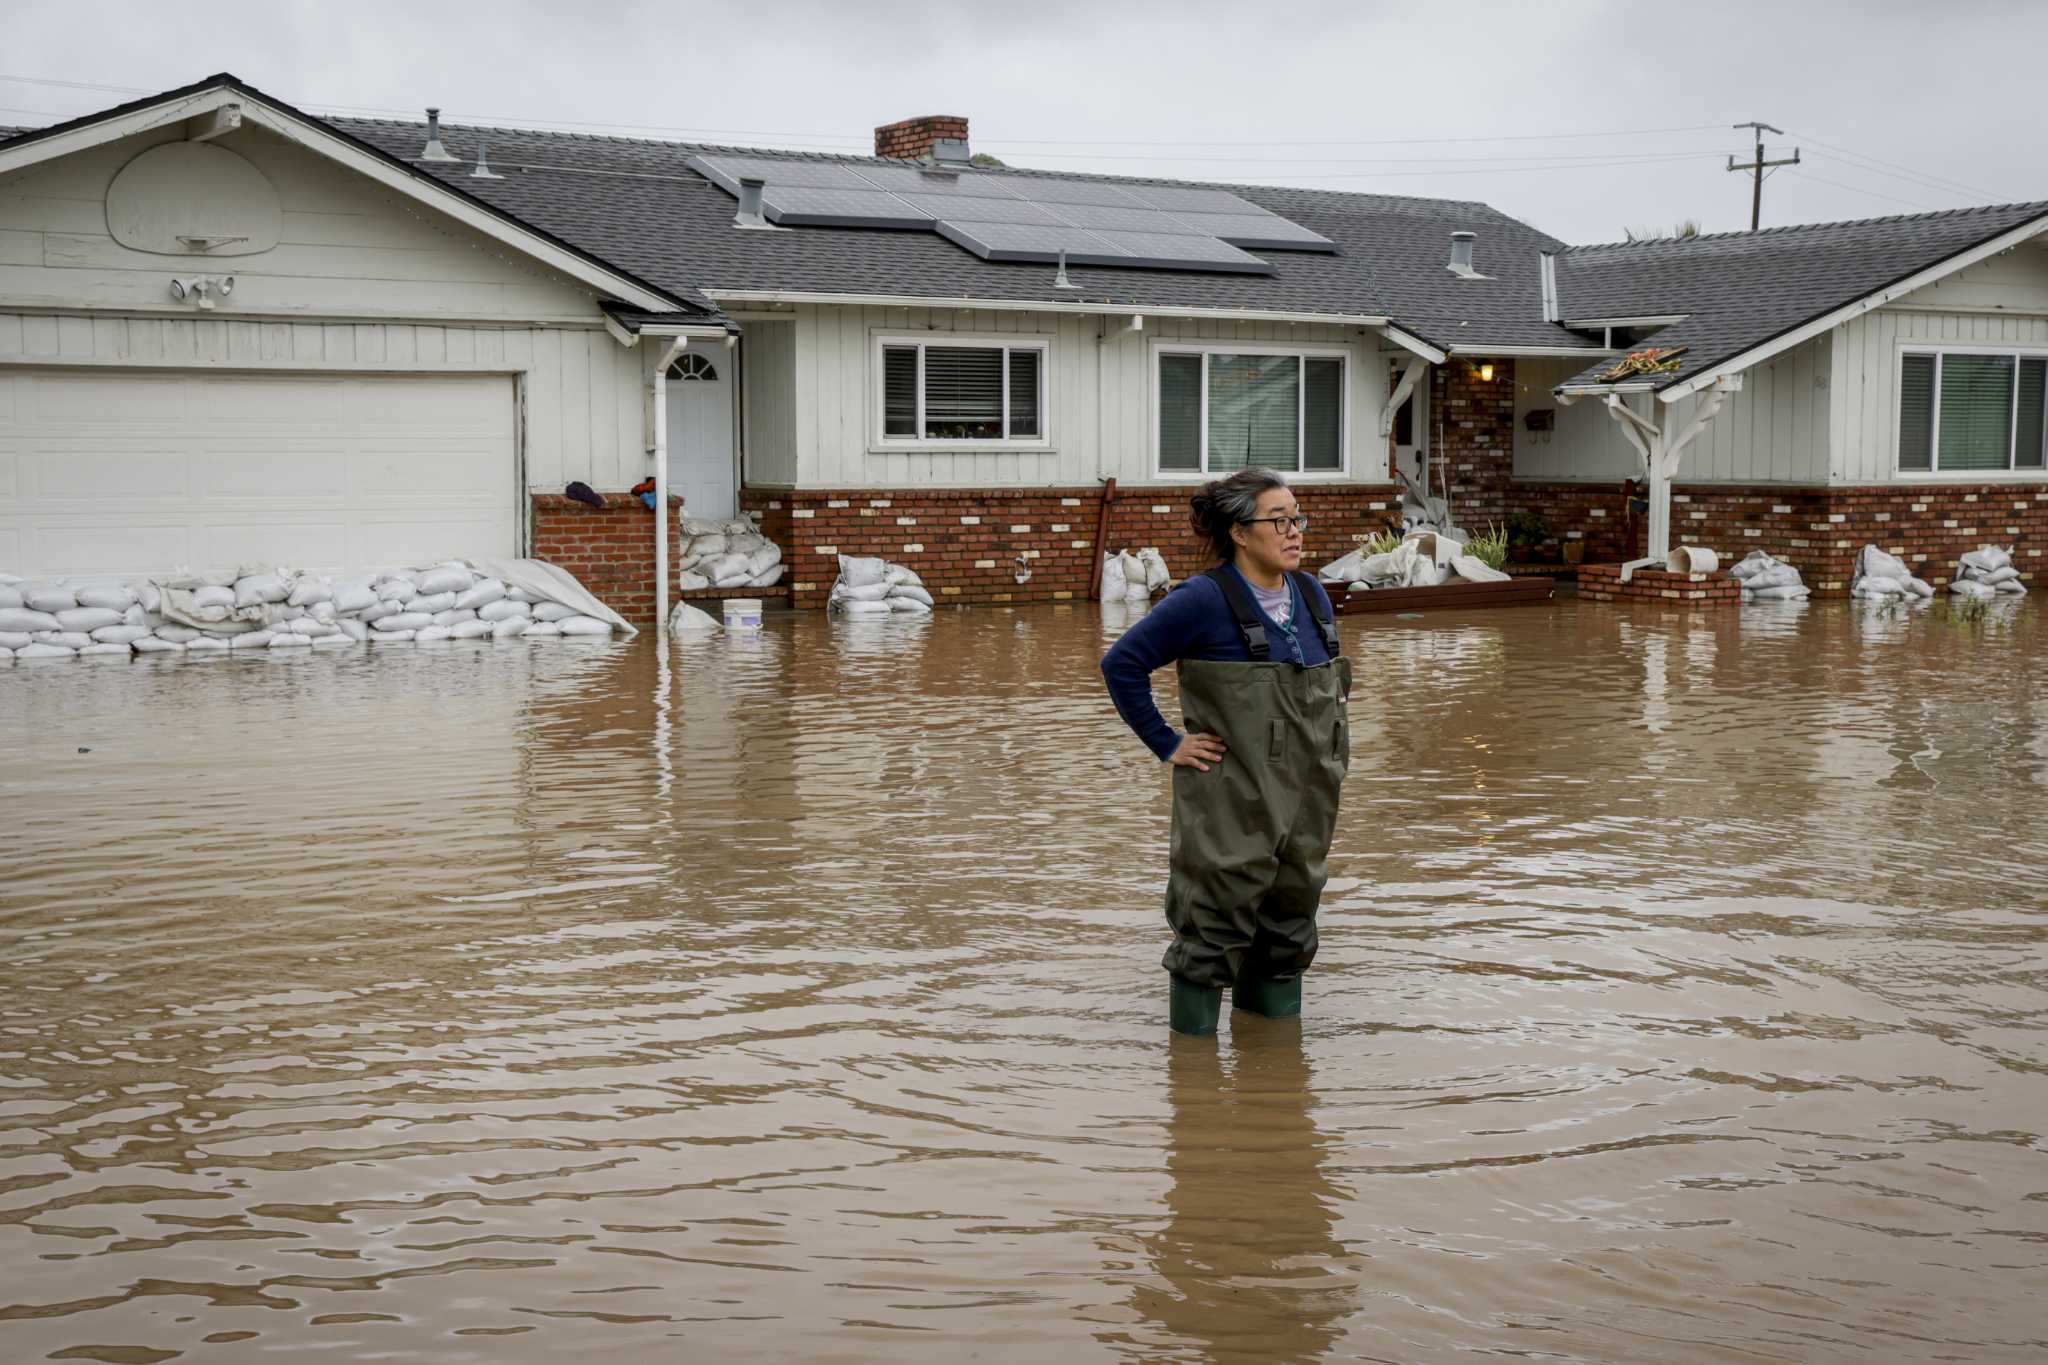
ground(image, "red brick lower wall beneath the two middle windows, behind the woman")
xmin=741 ymin=483 xmax=1399 ymax=608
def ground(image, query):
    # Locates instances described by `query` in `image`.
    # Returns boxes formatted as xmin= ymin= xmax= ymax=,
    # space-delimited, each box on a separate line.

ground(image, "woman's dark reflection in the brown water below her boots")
xmin=1133 ymin=1031 xmax=1358 ymax=1361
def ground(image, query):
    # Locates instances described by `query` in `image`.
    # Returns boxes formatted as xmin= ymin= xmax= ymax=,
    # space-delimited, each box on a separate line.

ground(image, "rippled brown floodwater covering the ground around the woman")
xmin=0 ymin=602 xmax=2048 ymax=1361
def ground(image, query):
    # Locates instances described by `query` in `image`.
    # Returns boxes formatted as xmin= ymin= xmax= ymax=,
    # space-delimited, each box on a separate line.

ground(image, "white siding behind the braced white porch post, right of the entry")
xmin=1516 ymin=338 xmax=1833 ymax=483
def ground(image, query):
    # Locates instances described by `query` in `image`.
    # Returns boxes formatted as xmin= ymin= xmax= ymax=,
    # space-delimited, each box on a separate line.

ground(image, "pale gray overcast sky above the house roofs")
xmin=0 ymin=0 xmax=2048 ymax=241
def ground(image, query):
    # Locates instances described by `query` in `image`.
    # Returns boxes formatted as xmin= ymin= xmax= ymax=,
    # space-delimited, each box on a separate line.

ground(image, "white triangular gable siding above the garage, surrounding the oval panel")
xmin=0 ymin=125 xmax=596 ymax=323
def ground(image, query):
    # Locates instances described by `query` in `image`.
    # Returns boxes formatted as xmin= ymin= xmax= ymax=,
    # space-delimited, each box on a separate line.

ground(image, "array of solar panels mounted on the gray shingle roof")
xmin=688 ymin=156 xmax=1337 ymax=274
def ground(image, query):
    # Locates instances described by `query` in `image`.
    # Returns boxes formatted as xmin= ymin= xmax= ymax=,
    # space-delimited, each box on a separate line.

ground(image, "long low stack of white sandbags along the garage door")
xmin=0 ymin=559 xmax=631 ymax=659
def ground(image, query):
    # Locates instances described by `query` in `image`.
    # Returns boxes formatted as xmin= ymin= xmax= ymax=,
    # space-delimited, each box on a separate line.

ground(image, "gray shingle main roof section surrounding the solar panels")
xmin=332 ymin=119 xmax=1591 ymax=348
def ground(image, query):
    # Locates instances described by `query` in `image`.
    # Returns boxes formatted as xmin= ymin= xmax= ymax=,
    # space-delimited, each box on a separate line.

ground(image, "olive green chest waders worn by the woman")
xmin=1165 ymin=571 xmax=1352 ymax=1033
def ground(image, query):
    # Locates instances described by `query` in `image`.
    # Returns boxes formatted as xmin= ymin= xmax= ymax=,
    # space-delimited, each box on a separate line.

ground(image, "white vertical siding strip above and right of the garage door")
xmin=0 ymin=313 xmax=649 ymax=493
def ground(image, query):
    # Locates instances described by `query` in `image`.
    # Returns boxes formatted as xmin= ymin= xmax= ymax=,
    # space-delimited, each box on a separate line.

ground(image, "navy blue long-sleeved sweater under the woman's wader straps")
xmin=1102 ymin=567 xmax=1329 ymax=761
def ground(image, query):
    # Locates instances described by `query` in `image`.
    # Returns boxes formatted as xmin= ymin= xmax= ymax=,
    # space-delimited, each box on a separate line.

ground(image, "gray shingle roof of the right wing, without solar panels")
xmin=1556 ymin=203 xmax=2048 ymax=389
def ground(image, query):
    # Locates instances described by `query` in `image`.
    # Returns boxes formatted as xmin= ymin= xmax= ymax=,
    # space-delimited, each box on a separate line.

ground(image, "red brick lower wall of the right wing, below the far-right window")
xmin=1511 ymin=483 xmax=2048 ymax=596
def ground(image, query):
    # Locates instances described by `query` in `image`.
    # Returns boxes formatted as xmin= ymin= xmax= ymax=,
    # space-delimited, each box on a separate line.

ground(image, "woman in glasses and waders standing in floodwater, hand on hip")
xmin=1102 ymin=469 xmax=1352 ymax=1033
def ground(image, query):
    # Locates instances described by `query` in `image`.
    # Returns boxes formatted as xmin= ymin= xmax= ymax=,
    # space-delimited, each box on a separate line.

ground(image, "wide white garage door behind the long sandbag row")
xmin=0 ymin=366 xmax=520 ymax=575
